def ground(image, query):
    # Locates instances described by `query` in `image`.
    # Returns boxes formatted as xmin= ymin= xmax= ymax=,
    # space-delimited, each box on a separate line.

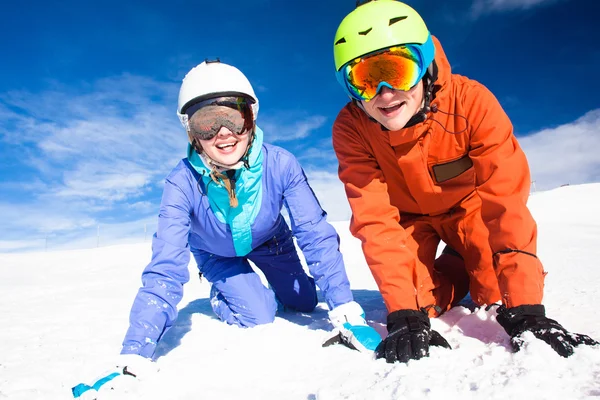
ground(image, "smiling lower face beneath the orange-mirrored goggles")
xmin=361 ymin=81 xmax=423 ymax=131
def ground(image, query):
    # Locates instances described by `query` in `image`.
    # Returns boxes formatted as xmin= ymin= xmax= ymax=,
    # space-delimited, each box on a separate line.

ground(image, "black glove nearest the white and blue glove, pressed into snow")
xmin=375 ymin=310 xmax=452 ymax=363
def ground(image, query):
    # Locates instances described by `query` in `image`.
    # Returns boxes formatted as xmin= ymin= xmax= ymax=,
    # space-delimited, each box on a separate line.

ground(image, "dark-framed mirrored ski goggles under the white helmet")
xmin=185 ymin=97 xmax=254 ymax=140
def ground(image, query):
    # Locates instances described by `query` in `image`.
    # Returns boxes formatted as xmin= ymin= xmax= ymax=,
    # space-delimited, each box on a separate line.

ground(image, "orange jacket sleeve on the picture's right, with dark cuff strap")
xmin=463 ymin=82 xmax=545 ymax=307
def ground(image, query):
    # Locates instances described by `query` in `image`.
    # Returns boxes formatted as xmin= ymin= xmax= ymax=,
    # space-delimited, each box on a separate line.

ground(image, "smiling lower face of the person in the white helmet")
xmin=198 ymin=127 xmax=250 ymax=165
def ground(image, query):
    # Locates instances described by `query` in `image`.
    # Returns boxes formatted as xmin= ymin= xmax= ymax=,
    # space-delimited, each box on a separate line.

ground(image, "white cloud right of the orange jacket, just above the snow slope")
xmin=519 ymin=109 xmax=600 ymax=190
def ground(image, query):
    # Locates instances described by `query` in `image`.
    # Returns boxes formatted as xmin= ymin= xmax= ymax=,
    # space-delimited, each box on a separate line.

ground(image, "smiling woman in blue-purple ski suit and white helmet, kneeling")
xmin=122 ymin=62 xmax=380 ymax=358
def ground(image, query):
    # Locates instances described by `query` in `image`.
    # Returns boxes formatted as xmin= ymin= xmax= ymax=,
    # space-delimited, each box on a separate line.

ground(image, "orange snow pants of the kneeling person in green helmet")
xmin=400 ymin=193 xmax=500 ymax=317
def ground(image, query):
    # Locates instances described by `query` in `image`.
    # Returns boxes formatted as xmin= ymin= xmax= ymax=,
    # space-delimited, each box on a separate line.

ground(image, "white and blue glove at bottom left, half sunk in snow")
xmin=71 ymin=354 xmax=159 ymax=400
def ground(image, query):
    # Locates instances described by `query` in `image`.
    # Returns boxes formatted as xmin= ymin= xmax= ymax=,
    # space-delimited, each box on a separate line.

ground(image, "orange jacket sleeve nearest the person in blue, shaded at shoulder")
xmin=333 ymin=106 xmax=417 ymax=312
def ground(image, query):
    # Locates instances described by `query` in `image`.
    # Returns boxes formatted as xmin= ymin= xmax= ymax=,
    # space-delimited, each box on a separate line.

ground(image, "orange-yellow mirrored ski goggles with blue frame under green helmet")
xmin=339 ymin=45 xmax=424 ymax=101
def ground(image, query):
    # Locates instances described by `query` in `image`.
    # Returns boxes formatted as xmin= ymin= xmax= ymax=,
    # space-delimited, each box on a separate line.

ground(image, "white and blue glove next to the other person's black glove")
xmin=323 ymin=301 xmax=381 ymax=352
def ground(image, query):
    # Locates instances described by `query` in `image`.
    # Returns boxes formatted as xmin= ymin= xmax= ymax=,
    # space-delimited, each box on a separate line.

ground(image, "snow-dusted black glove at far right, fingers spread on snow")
xmin=496 ymin=304 xmax=598 ymax=357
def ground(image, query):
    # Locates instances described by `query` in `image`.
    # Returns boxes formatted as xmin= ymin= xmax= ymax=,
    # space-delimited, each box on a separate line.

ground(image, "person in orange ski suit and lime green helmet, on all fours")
xmin=333 ymin=0 xmax=596 ymax=362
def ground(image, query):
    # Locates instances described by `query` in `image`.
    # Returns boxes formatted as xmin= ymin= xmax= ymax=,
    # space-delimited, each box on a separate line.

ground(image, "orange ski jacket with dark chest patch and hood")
xmin=333 ymin=38 xmax=545 ymax=312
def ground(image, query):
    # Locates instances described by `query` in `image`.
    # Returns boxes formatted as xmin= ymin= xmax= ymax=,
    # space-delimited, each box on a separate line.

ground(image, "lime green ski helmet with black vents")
xmin=333 ymin=0 xmax=435 ymax=97
